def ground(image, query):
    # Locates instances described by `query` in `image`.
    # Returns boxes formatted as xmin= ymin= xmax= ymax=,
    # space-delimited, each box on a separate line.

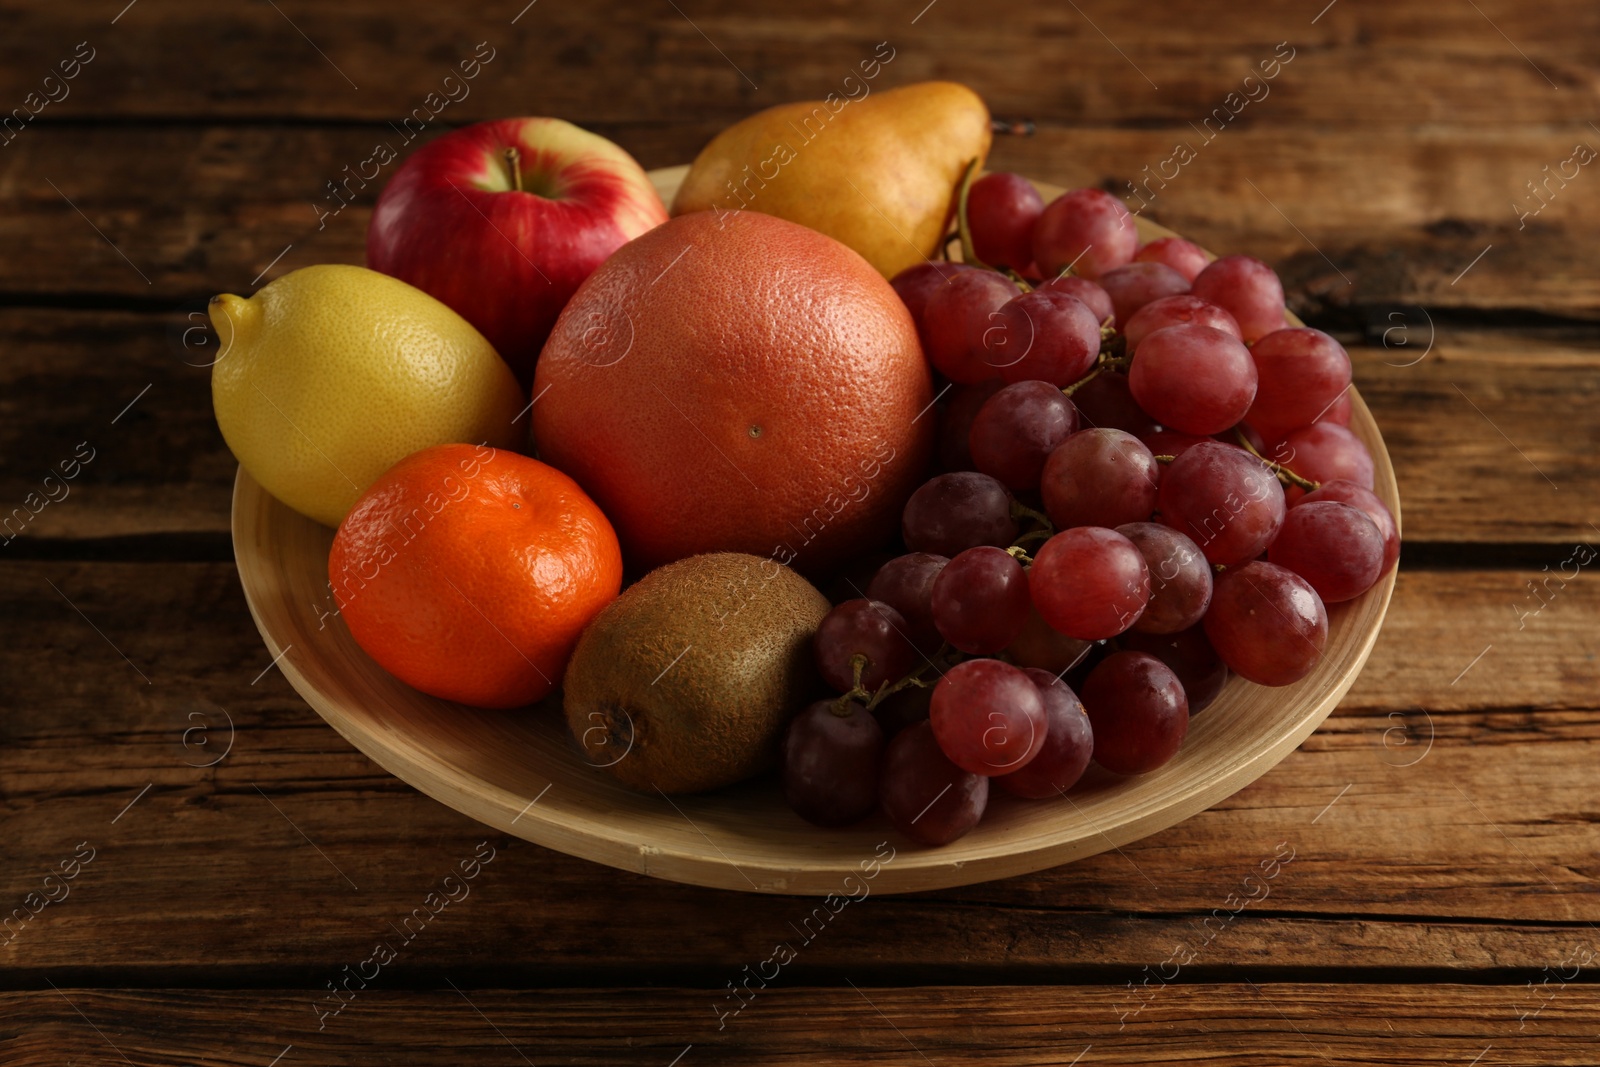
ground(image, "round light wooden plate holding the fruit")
xmin=234 ymin=168 xmax=1400 ymax=894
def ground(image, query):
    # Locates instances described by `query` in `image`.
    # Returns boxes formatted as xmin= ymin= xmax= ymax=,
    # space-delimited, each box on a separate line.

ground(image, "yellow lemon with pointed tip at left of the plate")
xmin=211 ymin=266 xmax=526 ymax=526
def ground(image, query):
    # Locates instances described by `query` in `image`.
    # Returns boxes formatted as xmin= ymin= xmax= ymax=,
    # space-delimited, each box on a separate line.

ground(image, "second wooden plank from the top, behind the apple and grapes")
xmin=0 ymin=118 xmax=1600 ymax=317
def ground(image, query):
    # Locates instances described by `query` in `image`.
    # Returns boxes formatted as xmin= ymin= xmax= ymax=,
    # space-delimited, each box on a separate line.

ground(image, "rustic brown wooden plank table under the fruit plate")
xmin=0 ymin=0 xmax=1600 ymax=1067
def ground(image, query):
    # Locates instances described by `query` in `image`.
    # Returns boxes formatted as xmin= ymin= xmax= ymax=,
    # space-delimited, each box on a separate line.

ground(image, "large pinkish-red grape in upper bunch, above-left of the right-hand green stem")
xmin=1128 ymin=323 xmax=1256 ymax=434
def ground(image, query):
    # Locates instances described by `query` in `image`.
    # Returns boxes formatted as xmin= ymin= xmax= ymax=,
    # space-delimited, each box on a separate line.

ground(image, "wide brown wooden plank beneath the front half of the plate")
xmin=0 ymin=563 xmax=1600 ymax=985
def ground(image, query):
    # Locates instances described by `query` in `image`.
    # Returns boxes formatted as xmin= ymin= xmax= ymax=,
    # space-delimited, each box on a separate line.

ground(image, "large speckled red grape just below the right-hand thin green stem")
xmin=1158 ymin=442 xmax=1286 ymax=566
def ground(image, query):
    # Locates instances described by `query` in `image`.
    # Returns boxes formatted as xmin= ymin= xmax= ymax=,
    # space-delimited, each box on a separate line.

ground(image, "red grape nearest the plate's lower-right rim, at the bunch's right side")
xmin=1205 ymin=560 xmax=1328 ymax=685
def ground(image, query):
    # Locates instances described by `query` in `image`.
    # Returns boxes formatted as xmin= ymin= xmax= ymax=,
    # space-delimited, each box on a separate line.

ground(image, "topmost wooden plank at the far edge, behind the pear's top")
xmin=0 ymin=0 xmax=1600 ymax=128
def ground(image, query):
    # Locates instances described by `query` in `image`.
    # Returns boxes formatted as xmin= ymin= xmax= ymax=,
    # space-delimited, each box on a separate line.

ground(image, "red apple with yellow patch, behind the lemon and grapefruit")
xmin=366 ymin=118 xmax=667 ymax=386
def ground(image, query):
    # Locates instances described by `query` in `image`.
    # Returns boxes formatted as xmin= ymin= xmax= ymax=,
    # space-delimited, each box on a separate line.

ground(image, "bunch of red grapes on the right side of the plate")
xmin=782 ymin=173 xmax=1400 ymax=845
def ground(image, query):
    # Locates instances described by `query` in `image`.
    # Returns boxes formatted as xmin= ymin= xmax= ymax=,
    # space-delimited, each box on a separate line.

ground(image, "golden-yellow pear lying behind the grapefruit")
xmin=672 ymin=82 xmax=990 ymax=278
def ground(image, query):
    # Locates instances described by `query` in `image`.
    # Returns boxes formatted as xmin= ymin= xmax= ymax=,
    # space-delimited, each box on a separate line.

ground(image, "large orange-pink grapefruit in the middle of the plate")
xmin=533 ymin=211 xmax=936 ymax=574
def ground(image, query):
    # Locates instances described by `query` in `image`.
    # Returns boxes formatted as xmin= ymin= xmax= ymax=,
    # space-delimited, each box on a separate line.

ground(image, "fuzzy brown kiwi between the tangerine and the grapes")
xmin=563 ymin=552 xmax=829 ymax=793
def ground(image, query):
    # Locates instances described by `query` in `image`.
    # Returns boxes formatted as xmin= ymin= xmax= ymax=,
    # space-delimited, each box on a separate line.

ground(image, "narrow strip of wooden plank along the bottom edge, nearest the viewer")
xmin=0 ymin=985 xmax=1600 ymax=1067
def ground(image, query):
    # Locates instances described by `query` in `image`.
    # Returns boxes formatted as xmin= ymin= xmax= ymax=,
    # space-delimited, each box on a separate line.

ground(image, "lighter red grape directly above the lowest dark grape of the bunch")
xmin=928 ymin=659 xmax=1050 ymax=777
